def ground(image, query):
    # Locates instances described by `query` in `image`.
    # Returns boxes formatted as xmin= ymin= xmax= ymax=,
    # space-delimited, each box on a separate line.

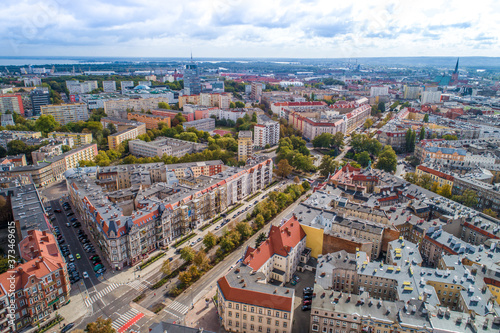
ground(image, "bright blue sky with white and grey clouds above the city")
xmin=0 ymin=0 xmax=500 ymax=58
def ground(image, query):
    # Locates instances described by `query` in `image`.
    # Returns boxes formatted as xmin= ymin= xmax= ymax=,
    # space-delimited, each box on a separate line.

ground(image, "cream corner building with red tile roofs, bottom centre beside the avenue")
xmin=217 ymin=217 xmax=306 ymax=333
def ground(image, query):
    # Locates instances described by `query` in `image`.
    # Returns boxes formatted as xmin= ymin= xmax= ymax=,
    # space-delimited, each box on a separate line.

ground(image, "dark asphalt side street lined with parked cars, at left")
xmin=50 ymin=200 xmax=105 ymax=289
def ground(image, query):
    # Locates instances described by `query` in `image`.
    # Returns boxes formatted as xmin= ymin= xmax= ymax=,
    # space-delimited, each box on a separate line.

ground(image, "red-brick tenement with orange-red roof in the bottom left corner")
xmin=0 ymin=230 xmax=71 ymax=332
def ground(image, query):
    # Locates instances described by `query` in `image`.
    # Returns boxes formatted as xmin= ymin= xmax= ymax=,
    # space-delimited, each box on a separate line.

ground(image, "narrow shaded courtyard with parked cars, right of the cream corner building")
xmin=285 ymin=271 xmax=314 ymax=332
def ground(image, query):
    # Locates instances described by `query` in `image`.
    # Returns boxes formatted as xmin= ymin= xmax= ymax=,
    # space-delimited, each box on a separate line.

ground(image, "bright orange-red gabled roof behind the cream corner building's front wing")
xmin=243 ymin=216 xmax=306 ymax=270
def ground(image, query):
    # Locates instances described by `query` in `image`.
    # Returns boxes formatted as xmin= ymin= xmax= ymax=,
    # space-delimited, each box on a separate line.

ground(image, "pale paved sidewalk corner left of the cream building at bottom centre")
xmin=184 ymin=288 xmax=225 ymax=333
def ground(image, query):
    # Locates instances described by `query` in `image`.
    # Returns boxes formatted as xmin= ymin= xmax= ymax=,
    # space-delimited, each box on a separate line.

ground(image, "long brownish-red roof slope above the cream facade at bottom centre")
xmin=217 ymin=274 xmax=292 ymax=312
